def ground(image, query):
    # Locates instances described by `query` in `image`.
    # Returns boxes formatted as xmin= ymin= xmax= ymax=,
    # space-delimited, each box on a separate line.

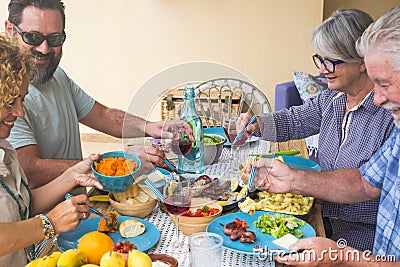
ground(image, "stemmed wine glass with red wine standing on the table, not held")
xmin=163 ymin=175 xmax=192 ymax=252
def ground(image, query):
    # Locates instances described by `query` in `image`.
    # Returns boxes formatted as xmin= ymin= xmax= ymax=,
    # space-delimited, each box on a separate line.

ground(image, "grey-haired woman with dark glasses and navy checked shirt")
xmin=239 ymin=9 xmax=394 ymax=251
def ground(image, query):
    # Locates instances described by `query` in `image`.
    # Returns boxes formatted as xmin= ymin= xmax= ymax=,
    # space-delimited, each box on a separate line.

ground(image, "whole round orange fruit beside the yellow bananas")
xmin=78 ymin=231 xmax=114 ymax=265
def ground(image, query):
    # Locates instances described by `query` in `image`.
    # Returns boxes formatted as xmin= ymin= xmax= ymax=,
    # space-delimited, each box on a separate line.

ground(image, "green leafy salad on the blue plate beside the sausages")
xmin=254 ymin=213 xmax=306 ymax=238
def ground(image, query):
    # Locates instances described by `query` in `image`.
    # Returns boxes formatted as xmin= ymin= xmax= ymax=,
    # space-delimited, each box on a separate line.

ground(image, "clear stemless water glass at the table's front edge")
xmin=189 ymin=232 xmax=224 ymax=267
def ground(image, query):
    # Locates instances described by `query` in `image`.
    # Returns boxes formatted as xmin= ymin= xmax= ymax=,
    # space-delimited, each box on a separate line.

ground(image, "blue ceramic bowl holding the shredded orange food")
xmin=91 ymin=151 xmax=142 ymax=193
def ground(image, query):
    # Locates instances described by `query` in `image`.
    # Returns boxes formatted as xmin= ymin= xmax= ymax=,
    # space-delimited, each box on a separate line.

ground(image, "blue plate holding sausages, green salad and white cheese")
xmin=206 ymin=211 xmax=316 ymax=255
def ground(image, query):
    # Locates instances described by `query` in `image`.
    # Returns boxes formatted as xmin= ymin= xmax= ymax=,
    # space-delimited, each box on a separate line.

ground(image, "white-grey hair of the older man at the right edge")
xmin=357 ymin=6 xmax=400 ymax=71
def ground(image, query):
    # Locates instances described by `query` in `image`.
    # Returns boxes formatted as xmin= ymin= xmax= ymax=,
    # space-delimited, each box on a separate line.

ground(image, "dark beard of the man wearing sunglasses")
xmin=31 ymin=48 xmax=62 ymax=85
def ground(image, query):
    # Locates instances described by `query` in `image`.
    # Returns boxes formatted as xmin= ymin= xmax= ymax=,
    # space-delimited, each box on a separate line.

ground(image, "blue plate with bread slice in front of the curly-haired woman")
xmin=57 ymin=216 xmax=160 ymax=252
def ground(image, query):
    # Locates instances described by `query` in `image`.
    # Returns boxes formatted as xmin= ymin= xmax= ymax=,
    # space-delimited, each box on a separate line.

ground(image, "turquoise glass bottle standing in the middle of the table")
xmin=178 ymin=84 xmax=204 ymax=173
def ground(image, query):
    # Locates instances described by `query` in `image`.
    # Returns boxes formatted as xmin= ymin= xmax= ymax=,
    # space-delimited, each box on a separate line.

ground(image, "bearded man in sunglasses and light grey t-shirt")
xmin=5 ymin=0 xmax=191 ymax=193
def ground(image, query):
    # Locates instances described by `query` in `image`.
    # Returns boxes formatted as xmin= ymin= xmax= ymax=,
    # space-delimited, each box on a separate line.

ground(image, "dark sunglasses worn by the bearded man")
xmin=14 ymin=25 xmax=67 ymax=47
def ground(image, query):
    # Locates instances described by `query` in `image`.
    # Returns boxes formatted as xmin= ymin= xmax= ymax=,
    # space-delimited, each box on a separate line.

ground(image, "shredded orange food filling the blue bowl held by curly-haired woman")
xmin=94 ymin=157 xmax=138 ymax=176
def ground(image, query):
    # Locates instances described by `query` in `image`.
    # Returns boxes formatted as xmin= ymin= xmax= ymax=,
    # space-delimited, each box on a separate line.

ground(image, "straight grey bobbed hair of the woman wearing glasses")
xmin=312 ymin=9 xmax=374 ymax=62
